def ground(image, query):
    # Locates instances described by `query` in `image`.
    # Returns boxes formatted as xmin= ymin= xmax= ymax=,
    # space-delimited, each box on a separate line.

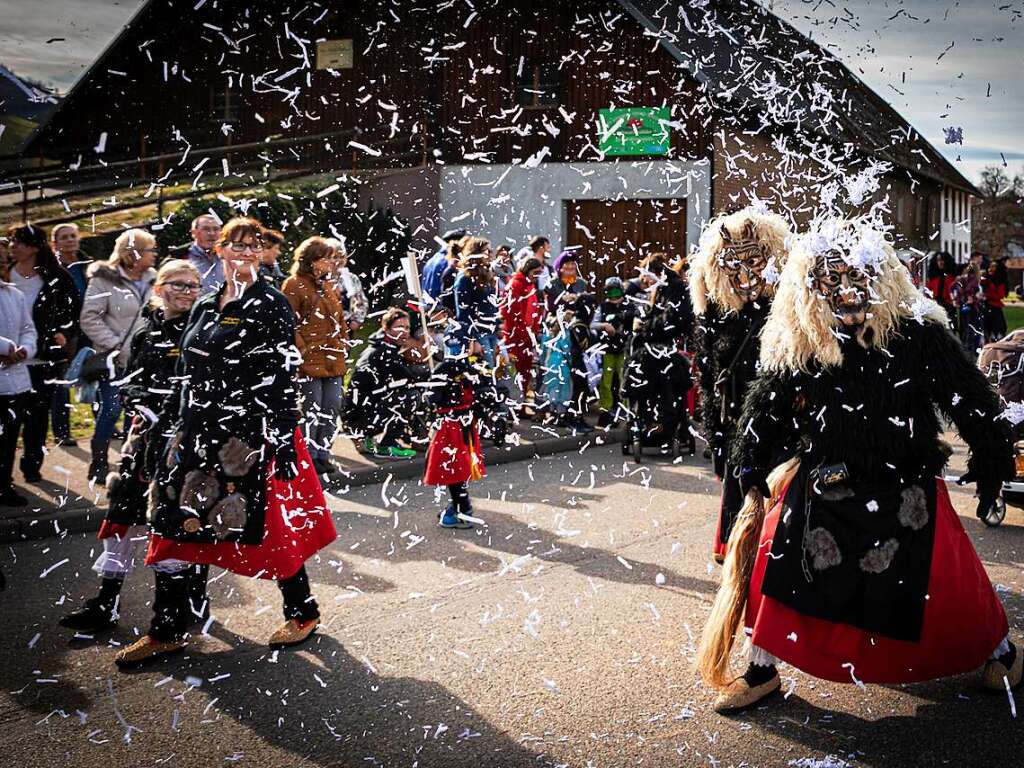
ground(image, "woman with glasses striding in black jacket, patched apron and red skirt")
xmin=115 ymin=218 xmax=336 ymax=668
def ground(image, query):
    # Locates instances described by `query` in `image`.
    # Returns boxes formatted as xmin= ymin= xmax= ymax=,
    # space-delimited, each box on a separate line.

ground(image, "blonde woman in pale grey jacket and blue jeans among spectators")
xmin=82 ymin=229 xmax=157 ymax=482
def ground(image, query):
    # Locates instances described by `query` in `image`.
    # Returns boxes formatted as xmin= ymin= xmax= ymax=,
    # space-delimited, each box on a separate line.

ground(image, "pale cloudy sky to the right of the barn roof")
xmin=771 ymin=0 xmax=1024 ymax=182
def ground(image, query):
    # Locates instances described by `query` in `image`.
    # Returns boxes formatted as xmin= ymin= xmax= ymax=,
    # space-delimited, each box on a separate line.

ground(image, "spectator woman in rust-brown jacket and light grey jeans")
xmin=281 ymin=238 xmax=348 ymax=474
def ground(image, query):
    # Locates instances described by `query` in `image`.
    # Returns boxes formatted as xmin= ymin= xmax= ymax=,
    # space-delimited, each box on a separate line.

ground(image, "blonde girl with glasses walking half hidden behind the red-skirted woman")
xmin=60 ymin=259 xmax=207 ymax=634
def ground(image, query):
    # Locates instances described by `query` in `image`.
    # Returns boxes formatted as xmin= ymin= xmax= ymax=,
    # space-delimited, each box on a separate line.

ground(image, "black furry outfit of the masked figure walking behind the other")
xmin=695 ymin=298 xmax=770 ymax=559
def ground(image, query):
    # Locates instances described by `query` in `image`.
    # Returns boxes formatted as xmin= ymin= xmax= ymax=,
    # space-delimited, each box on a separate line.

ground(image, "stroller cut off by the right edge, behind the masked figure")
xmin=978 ymin=329 xmax=1024 ymax=527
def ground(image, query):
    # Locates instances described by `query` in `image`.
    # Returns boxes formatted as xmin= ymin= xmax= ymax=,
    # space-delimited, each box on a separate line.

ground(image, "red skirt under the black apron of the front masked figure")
xmin=746 ymin=479 xmax=1009 ymax=683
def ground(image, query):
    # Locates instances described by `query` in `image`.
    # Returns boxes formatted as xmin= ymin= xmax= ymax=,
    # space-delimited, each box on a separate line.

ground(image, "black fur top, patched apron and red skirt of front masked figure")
xmin=732 ymin=319 xmax=1013 ymax=683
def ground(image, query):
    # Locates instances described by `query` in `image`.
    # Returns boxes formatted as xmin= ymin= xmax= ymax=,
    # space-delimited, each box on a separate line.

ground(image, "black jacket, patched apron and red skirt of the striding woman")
xmin=146 ymin=280 xmax=336 ymax=580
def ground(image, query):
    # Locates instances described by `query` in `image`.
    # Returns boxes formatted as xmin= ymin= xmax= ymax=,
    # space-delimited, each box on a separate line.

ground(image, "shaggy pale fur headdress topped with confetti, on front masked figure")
xmin=761 ymin=219 xmax=949 ymax=372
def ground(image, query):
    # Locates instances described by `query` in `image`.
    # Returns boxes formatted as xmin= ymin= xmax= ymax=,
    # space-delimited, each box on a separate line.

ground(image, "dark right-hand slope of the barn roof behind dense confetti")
xmin=618 ymin=0 xmax=978 ymax=195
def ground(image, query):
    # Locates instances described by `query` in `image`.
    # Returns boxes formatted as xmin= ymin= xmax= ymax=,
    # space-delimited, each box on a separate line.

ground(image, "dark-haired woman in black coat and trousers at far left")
xmin=9 ymin=224 xmax=82 ymax=482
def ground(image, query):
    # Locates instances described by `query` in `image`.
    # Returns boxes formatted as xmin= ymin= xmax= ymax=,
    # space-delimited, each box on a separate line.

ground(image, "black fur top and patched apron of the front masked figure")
xmin=732 ymin=319 xmax=1013 ymax=641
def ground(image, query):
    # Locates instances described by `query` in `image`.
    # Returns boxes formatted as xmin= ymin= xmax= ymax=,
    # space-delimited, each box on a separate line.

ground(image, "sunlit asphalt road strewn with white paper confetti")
xmin=0 ymin=446 xmax=1024 ymax=768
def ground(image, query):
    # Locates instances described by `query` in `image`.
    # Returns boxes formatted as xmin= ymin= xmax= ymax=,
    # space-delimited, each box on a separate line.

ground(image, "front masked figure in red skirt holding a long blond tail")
xmin=698 ymin=220 xmax=1022 ymax=712
